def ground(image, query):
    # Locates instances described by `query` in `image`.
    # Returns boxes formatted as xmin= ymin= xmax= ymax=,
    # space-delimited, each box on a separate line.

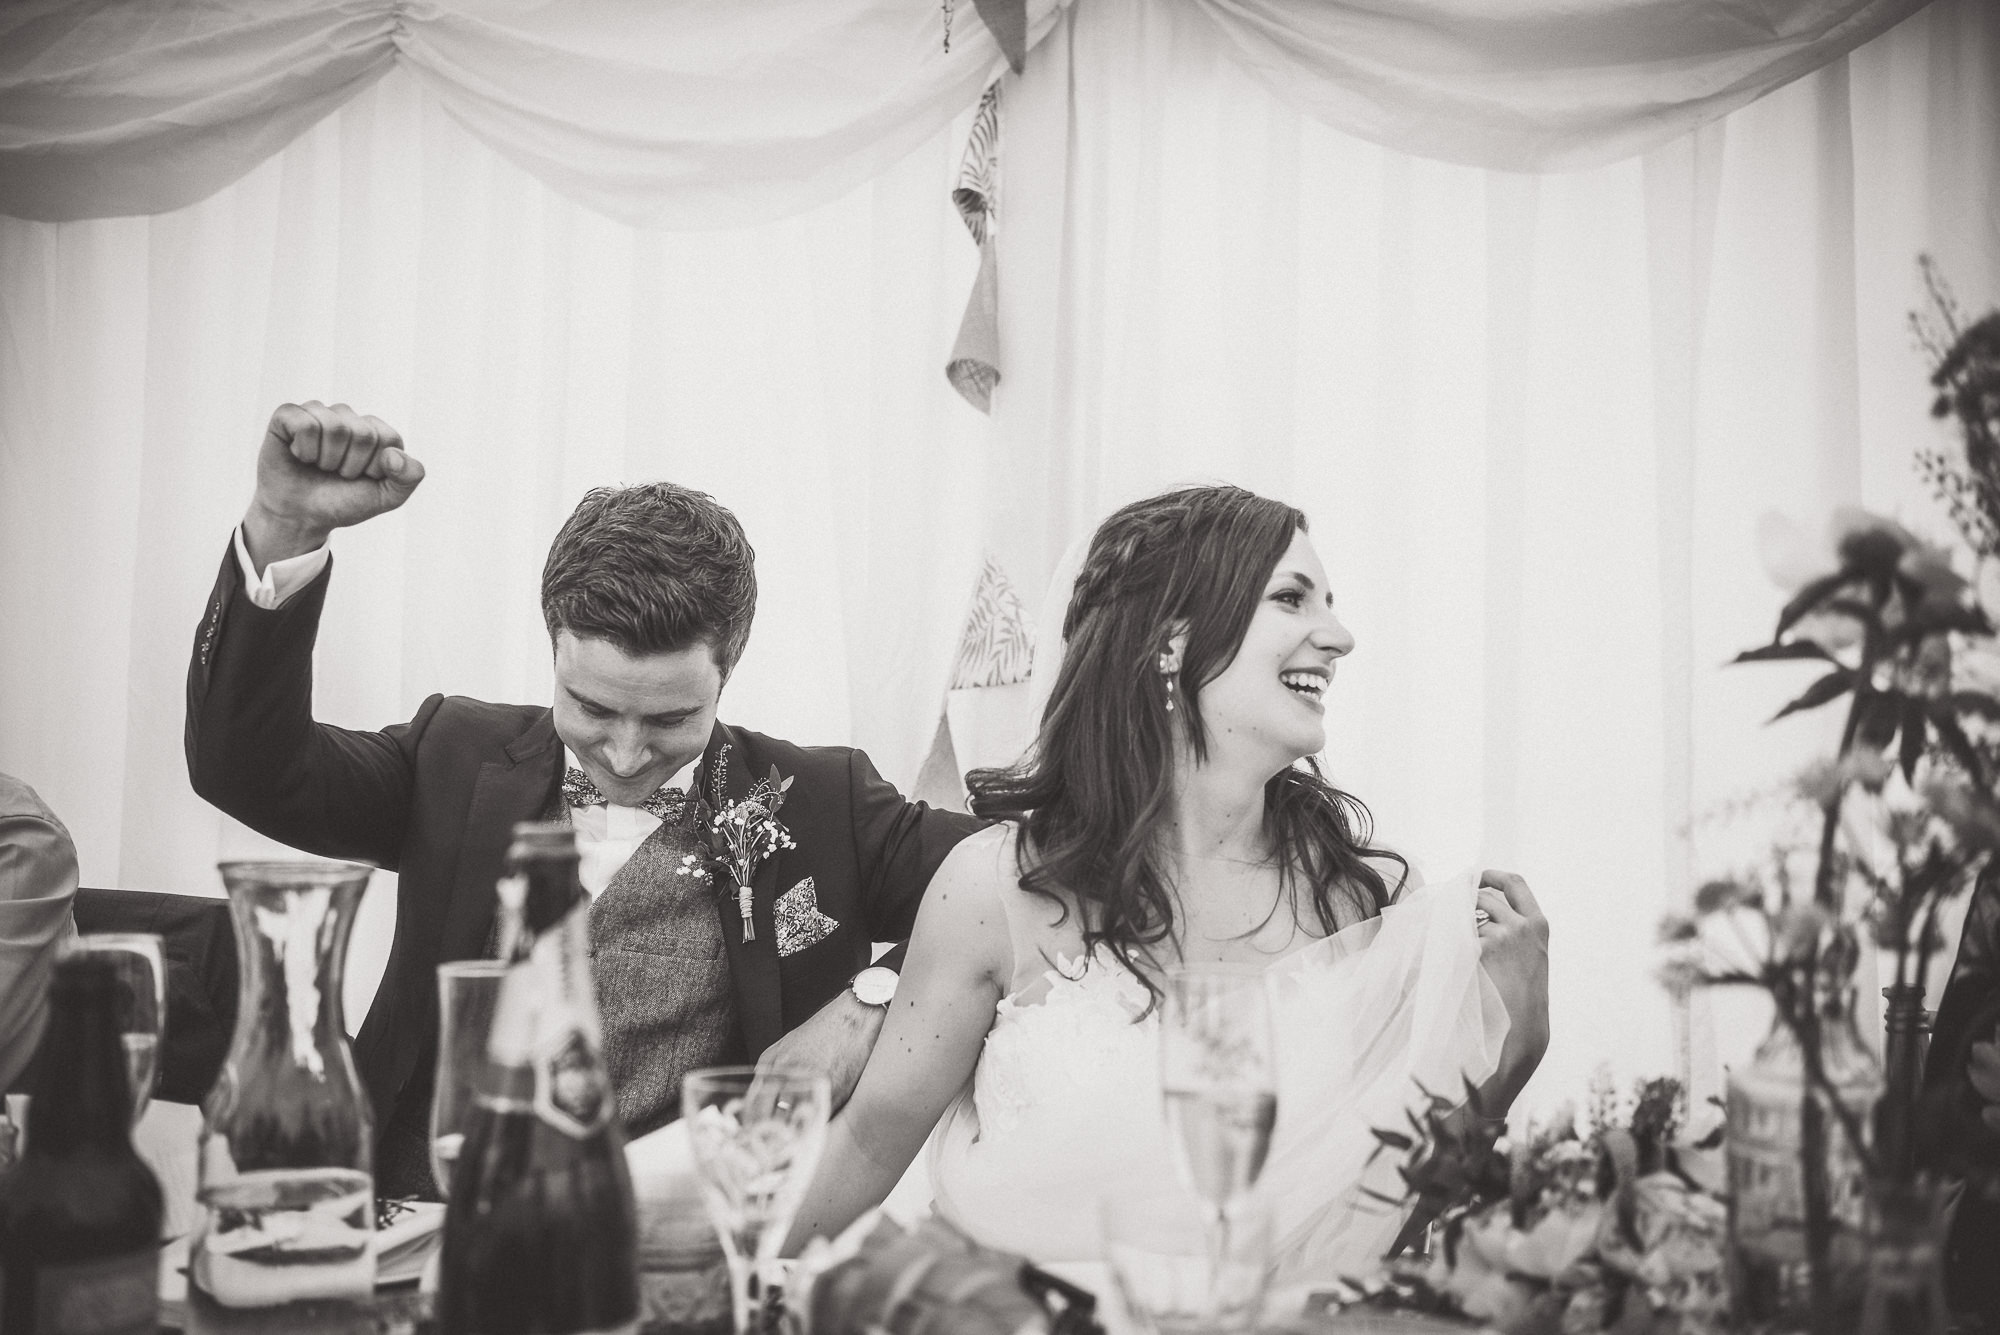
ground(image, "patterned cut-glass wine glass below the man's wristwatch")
xmin=680 ymin=1067 xmax=832 ymax=1335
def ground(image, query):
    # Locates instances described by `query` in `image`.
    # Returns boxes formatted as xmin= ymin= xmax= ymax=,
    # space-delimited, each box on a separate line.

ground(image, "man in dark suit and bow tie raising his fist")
xmin=186 ymin=402 xmax=978 ymax=1195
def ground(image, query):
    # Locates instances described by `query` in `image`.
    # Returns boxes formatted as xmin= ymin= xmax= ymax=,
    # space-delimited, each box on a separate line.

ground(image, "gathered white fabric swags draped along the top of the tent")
xmin=0 ymin=0 xmax=1924 ymax=228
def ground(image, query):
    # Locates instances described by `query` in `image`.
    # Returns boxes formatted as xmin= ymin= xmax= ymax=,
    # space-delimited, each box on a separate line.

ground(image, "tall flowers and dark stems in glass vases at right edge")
xmin=1662 ymin=260 xmax=2000 ymax=1331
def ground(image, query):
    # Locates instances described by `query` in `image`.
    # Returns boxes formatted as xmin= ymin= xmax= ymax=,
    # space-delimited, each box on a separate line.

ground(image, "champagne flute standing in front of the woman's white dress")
xmin=1160 ymin=963 xmax=1278 ymax=1311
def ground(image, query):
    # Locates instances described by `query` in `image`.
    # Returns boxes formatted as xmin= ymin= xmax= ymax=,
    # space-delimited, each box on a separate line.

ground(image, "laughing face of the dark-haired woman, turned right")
xmin=1202 ymin=534 xmax=1354 ymax=773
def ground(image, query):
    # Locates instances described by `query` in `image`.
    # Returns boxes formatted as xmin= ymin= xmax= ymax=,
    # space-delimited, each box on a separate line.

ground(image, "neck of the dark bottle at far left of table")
xmin=26 ymin=975 xmax=132 ymax=1157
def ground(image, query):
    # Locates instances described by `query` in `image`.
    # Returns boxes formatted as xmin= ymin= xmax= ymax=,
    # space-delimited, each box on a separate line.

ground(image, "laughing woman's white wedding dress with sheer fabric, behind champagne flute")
xmin=930 ymin=875 xmax=1506 ymax=1281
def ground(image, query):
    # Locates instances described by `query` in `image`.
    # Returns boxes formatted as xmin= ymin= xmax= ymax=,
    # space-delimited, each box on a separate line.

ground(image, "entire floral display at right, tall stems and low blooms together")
xmin=1370 ymin=260 xmax=2000 ymax=1335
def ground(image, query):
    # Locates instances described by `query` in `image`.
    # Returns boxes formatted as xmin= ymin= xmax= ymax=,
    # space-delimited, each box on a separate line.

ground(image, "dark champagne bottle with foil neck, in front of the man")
xmin=438 ymin=823 xmax=638 ymax=1335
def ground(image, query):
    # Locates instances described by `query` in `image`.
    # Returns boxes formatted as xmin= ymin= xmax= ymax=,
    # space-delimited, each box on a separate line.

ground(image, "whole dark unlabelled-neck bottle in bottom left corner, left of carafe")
xmin=0 ymin=955 xmax=160 ymax=1335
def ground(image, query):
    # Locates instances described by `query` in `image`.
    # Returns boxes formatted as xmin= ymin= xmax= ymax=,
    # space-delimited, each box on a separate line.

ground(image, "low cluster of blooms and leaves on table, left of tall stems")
xmin=1362 ymin=1075 xmax=1728 ymax=1335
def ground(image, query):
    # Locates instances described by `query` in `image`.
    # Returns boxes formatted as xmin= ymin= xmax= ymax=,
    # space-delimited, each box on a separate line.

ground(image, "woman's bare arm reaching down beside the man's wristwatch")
xmin=784 ymin=825 xmax=1014 ymax=1255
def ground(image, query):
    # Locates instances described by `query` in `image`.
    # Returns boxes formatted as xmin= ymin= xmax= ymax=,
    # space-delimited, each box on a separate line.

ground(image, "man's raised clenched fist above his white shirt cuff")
xmin=244 ymin=400 xmax=424 ymax=570
